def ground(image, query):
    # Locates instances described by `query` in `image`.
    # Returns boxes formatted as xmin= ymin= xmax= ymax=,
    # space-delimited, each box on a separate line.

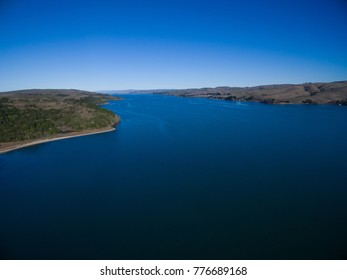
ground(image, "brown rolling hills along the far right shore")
xmin=153 ymin=81 xmax=347 ymax=105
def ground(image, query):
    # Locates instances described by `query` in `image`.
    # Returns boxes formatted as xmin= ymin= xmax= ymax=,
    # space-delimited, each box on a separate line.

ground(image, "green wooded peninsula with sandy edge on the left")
xmin=0 ymin=89 xmax=120 ymax=153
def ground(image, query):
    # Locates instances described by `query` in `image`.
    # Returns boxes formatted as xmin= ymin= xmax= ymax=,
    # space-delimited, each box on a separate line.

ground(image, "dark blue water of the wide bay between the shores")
xmin=0 ymin=95 xmax=347 ymax=259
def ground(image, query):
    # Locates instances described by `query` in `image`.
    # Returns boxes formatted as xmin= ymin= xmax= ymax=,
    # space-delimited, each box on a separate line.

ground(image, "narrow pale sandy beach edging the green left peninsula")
xmin=0 ymin=127 xmax=116 ymax=154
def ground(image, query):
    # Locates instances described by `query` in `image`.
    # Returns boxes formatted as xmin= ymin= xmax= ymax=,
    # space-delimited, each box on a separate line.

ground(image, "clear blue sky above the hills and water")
xmin=0 ymin=0 xmax=347 ymax=91
